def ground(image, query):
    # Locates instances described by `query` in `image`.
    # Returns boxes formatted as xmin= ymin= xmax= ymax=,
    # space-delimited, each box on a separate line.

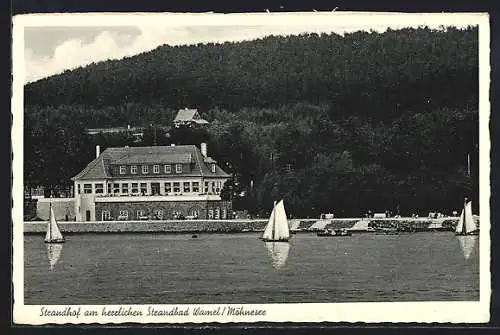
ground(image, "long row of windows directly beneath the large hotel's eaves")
xmin=78 ymin=181 xmax=222 ymax=195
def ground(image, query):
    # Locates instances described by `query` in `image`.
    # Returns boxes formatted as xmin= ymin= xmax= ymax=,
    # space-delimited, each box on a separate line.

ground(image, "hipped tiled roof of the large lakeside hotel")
xmin=71 ymin=145 xmax=230 ymax=181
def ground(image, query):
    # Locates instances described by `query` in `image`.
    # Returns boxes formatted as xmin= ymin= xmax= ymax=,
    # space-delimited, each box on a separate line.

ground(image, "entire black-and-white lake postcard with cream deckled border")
xmin=12 ymin=11 xmax=491 ymax=325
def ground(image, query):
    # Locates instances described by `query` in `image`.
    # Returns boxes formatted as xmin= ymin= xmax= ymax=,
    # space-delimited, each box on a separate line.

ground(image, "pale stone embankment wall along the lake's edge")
xmin=23 ymin=217 xmax=458 ymax=235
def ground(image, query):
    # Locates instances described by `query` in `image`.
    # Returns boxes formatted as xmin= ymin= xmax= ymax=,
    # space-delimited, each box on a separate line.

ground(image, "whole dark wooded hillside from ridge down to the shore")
xmin=24 ymin=27 xmax=479 ymax=216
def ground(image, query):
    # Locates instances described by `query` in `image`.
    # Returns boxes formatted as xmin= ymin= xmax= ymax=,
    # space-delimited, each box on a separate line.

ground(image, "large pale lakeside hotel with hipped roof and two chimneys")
xmin=72 ymin=143 xmax=232 ymax=221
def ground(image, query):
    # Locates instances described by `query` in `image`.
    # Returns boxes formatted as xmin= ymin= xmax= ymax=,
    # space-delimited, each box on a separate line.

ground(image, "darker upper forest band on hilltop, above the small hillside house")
xmin=25 ymin=28 xmax=478 ymax=121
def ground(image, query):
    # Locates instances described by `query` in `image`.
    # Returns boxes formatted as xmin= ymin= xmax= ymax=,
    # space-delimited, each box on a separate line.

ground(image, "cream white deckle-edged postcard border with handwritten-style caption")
xmin=11 ymin=11 xmax=491 ymax=325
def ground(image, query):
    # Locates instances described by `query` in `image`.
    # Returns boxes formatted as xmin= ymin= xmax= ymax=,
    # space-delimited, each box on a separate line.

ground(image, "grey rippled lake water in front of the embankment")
xmin=24 ymin=232 xmax=479 ymax=305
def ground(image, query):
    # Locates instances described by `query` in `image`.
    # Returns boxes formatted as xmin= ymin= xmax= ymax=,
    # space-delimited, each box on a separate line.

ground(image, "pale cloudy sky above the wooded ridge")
xmin=24 ymin=13 xmax=476 ymax=83
